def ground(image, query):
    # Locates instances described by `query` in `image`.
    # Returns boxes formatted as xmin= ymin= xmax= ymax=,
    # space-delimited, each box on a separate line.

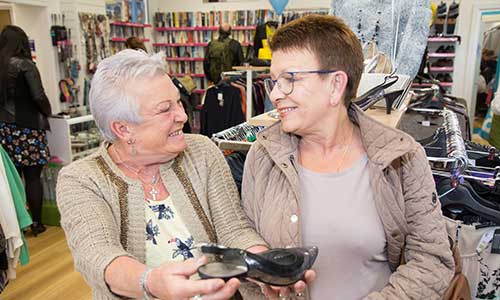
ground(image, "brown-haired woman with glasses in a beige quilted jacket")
xmin=242 ymin=15 xmax=454 ymax=300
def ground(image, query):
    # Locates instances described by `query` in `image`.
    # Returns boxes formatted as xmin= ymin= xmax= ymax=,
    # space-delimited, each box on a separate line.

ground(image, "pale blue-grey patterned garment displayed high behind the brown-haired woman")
xmin=332 ymin=0 xmax=431 ymax=79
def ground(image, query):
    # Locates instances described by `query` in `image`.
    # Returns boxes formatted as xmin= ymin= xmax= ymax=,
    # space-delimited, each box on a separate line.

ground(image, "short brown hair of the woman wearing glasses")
xmin=269 ymin=15 xmax=363 ymax=106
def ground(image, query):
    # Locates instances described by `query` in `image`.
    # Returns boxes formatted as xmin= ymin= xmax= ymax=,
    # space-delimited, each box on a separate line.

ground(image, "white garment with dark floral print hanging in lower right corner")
xmin=445 ymin=218 xmax=500 ymax=299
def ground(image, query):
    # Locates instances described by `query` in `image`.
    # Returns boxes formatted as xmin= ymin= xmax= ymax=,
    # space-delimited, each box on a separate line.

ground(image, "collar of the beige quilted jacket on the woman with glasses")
xmin=257 ymin=104 xmax=414 ymax=168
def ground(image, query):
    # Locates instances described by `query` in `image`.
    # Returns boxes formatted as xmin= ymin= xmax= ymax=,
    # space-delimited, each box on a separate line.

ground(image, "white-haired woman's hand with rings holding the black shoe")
xmin=147 ymin=257 xmax=240 ymax=300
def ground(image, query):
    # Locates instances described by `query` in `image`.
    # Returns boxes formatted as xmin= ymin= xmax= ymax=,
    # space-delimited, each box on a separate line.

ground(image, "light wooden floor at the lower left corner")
xmin=0 ymin=227 xmax=92 ymax=300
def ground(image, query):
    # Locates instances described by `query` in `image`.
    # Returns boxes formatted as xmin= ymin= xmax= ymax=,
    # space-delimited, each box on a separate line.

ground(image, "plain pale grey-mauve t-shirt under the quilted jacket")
xmin=298 ymin=155 xmax=391 ymax=300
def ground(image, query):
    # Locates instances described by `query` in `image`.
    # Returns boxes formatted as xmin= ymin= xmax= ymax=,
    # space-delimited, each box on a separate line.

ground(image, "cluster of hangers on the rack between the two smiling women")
xmin=212 ymin=122 xmax=265 ymax=151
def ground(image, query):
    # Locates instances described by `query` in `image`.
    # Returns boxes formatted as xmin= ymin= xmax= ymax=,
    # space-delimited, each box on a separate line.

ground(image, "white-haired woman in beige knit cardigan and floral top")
xmin=57 ymin=50 xmax=265 ymax=300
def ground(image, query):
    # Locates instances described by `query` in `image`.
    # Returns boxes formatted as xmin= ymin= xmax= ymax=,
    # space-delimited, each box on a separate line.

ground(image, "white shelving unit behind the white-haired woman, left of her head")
xmin=47 ymin=115 xmax=101 ymax=165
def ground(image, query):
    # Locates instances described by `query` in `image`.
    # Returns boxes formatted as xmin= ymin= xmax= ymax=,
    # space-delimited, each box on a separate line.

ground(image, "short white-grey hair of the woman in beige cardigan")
xmin=89 ymin=49 xmax=167 ymax=142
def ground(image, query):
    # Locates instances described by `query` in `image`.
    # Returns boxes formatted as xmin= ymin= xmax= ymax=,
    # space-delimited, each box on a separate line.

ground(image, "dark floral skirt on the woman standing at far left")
xmin=0 ymin=122 xmax=50 ymax=167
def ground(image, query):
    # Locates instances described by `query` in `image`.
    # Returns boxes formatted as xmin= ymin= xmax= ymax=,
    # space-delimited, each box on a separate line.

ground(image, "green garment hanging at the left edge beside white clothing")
xmin=0 ymin=146 xmax=33 ymax=266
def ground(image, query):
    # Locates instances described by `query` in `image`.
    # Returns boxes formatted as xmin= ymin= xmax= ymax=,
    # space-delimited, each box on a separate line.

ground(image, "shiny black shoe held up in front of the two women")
xmin=198 ymin=244 xmax=318 ymax=286
